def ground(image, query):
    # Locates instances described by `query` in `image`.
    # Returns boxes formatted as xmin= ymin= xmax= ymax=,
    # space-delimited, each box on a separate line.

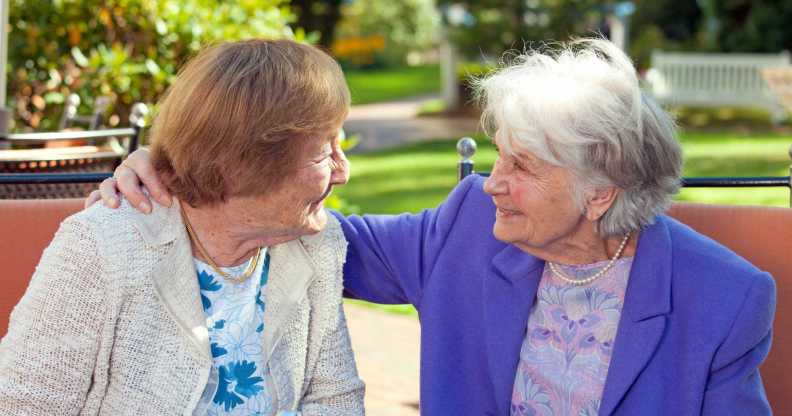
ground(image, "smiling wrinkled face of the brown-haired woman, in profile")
xmin=232 ymin=130 xmax=349 ymax=241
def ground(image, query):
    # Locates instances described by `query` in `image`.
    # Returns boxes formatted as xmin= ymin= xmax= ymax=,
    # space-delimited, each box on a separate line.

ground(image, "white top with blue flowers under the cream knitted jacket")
xmin=193 ymin=252 xmax=274 ymax=416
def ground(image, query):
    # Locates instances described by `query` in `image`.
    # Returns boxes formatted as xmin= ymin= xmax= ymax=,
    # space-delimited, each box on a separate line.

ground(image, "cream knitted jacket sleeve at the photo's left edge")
xmin=0 ymin=217 xmax=106 ymax=416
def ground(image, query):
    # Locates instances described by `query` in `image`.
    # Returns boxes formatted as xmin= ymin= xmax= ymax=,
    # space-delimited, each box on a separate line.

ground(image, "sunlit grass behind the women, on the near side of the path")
xmin=336 ymin=132 xmax=792 ymax=315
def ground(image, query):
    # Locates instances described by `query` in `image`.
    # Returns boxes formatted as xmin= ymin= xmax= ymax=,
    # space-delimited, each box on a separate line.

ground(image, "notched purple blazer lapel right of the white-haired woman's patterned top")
xmin=599 ymin=217 xmax=671 ymax=415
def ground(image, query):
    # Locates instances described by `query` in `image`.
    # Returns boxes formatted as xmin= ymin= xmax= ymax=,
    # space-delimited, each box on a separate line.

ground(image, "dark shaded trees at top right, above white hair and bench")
xmin=437 ymin=0 xmax=792 ymax=68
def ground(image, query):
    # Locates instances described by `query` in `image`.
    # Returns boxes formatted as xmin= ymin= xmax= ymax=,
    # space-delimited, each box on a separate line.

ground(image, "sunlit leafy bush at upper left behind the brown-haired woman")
xmin=8 ymin=0 xmax=296 ymax=130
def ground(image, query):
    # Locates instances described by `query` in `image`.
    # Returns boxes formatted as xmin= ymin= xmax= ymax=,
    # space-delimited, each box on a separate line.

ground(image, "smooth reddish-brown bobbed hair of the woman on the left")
xmin=151 ymin=40 xmax=349 ymax=206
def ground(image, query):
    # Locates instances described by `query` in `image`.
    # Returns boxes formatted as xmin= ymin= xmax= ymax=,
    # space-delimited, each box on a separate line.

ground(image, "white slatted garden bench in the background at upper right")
xmin=646 ymin=51 xmax=792 ymax=122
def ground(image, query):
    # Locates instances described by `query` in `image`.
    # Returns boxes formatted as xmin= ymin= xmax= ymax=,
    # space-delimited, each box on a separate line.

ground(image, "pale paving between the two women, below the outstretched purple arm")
xmin=344 ymin=304 xmax=420 ymax=416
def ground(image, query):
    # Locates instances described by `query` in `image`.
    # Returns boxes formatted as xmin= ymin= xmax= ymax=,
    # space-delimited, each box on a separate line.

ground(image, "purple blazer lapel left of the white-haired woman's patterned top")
xmin=483 ymin=245 xmax=544 ymax=415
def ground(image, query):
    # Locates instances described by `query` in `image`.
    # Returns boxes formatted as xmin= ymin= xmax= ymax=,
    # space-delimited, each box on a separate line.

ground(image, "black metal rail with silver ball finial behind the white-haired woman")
xmin=457 ymin=137 xmax=792 ymax=207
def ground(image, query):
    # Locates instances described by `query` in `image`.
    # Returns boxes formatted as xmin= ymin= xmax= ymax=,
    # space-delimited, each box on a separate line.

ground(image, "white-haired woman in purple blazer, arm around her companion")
xmin=94 ymin=40 xmax=775 ymax=416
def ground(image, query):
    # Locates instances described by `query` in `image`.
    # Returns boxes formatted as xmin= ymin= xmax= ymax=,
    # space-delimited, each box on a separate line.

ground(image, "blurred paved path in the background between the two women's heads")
xmin=344 ymin=95 xmax=478 ymax=152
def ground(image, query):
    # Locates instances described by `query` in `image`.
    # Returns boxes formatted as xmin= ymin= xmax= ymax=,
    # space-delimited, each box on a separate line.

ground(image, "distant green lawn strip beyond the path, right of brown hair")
xmin=345 ymin=65 xmax=440 ymax=104
